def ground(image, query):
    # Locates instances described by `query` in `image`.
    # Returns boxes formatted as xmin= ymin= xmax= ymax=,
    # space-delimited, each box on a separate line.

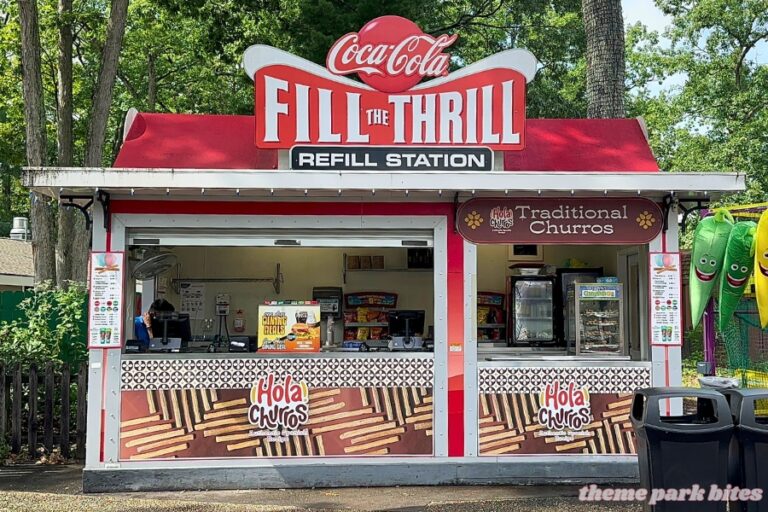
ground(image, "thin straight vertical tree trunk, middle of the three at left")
xmin=56 ymin=0 xmax=75 ymax=287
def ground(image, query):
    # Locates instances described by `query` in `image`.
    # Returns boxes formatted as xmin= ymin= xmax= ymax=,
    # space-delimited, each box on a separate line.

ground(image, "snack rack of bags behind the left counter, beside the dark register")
xmin=342 ymin=292 xmax=397 ymax=349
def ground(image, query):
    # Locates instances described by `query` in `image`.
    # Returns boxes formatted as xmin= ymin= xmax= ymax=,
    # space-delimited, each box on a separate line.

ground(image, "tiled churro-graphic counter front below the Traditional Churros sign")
xmin=478 ymin=362 xmax=651 ymax=456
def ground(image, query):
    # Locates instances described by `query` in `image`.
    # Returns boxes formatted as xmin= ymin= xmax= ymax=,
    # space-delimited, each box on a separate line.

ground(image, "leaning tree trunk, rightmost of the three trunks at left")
xmin=72 ymin=0 xmax=128 ymax=281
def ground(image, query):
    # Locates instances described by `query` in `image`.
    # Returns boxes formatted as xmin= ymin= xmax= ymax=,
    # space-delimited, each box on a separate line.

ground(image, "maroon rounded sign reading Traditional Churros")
xmin=456 ymin=197 xmax=663 ymax=245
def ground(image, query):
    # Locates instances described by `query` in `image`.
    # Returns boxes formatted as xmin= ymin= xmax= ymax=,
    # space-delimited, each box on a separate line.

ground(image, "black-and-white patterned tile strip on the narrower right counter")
xmin=478 ymin=366 xmax=651 ymax=393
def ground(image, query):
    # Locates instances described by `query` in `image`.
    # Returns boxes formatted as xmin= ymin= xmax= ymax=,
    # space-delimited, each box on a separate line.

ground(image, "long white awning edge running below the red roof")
xmin=23 ymin=167 xmax=745 ymax=200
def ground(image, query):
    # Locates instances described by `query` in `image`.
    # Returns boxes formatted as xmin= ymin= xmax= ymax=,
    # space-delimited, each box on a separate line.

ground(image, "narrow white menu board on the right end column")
xmin=649 ymin=252 xmax=683 ymax=346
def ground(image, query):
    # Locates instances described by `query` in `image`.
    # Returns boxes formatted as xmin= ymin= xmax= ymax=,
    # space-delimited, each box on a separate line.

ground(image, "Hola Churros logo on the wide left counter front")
xmin=248 ymin=373 xmax=309 ymax=430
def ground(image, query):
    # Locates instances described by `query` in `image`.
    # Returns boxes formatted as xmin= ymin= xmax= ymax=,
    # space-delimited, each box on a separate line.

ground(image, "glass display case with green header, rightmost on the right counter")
xmin=575 ymin=283 xmax=626 ymax=355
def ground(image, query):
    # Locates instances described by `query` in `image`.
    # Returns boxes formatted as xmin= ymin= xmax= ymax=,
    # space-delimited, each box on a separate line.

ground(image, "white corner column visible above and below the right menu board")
xmin=648 ymin=200 xmax=683 ymax=414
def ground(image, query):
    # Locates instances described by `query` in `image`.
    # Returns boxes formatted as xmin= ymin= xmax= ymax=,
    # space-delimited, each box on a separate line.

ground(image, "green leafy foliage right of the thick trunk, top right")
xmin=627 ymin=0 xmax=768 ymax=202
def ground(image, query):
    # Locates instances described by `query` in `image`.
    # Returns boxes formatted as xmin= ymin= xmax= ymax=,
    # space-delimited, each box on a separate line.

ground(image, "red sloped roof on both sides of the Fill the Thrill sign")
xmin=114 ymin=114 xmax=659 ymax=172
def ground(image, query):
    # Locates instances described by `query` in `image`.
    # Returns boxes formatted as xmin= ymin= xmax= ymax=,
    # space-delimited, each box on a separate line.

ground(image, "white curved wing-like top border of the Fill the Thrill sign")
xmin=243 ymin=44 xmax=538 ymax=87
